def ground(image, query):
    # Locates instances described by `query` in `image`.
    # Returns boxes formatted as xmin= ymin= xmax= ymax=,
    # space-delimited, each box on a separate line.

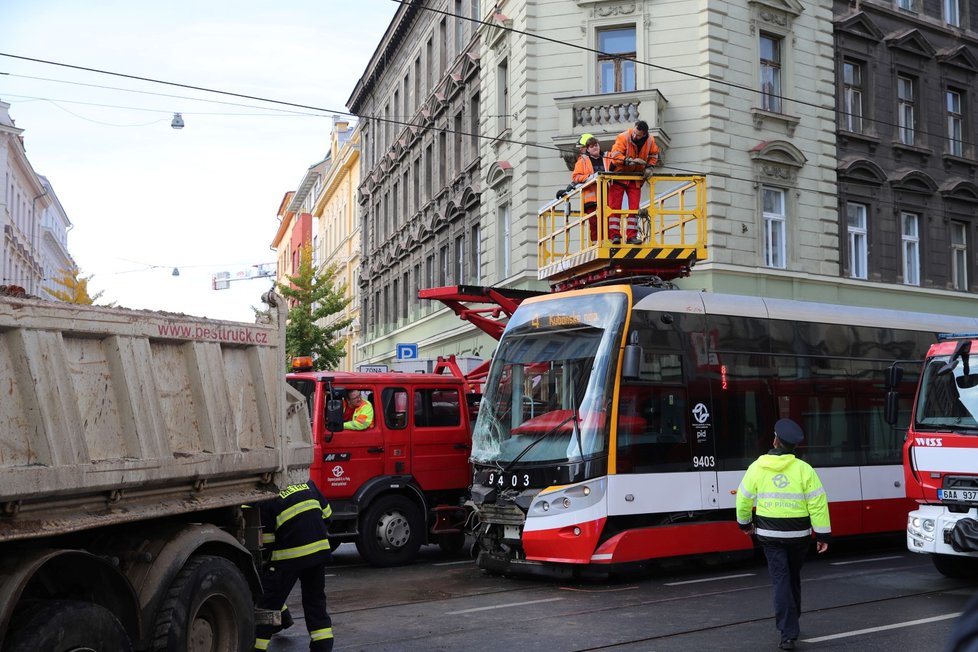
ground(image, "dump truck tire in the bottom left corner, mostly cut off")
xmin=3 ymin=600 xmax=132 ymax=652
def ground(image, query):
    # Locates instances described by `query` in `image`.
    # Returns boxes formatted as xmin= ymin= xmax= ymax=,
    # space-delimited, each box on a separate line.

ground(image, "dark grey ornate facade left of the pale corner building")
xmin=347 ymin=0 xmax=491 ymax=363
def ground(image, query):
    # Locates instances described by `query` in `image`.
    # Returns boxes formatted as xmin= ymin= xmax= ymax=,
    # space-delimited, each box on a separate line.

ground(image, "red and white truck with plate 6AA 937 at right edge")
xmin=886 ymin=332 xmax=978 ymax=577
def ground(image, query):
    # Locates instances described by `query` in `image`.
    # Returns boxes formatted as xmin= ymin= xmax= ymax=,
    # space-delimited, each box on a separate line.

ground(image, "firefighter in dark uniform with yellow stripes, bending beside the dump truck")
xmin=255 ymin=480 xmax=333 ymax=652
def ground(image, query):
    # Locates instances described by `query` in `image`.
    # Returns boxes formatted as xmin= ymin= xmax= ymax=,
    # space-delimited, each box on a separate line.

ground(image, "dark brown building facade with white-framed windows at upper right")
xmin=835 ymin=0 xmax=978 ymax=311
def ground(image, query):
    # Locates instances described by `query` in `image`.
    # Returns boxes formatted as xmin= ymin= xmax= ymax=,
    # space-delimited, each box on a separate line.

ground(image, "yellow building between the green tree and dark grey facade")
xmin=312 ymin=118 xmax=362 ymax=371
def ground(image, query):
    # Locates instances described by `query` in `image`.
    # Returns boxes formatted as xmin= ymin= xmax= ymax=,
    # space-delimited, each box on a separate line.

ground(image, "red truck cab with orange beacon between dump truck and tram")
xmin=287 ymin=364 xmax=478 ymax=566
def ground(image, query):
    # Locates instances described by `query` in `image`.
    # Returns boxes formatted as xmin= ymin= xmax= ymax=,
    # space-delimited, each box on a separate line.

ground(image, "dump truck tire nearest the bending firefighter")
xmin=153 ymin=555 xmax=255 ymax=652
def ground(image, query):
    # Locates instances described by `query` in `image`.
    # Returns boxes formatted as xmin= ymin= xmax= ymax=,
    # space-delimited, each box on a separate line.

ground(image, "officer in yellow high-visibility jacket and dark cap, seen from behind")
xmin=737 ymin=419 xmax=832 ymax=650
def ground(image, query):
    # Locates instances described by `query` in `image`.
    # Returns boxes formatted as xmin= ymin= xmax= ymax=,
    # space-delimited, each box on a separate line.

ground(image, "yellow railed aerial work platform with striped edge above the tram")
xmin=538 ymin=173 xmax=706 ymax=290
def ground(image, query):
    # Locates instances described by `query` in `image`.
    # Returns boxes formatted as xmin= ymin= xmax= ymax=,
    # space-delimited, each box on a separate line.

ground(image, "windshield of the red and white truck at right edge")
xmin=915 ymin=356 xmax=978 ymax=431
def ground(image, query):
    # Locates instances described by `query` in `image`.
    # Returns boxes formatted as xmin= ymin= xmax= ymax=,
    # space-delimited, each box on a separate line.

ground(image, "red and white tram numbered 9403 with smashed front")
xmin=472 ymin=285 xmax=978 ymax=572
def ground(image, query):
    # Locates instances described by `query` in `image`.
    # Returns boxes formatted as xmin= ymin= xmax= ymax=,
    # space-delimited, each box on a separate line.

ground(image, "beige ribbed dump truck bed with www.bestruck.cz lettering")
xmin=0 ymin=296 xmax=312 ymax=541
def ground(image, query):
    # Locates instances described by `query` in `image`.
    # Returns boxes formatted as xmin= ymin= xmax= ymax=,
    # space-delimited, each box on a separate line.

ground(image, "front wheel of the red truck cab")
xmin=357 ymin=496 xmax=424 ymax=567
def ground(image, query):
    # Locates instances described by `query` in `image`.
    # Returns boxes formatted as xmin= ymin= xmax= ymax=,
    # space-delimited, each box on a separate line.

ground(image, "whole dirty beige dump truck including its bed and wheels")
xmin=0 ymin=293 xmax=312 ymax=652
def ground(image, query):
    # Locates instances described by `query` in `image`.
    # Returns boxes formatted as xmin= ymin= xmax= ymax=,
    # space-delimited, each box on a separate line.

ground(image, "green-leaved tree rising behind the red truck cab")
xmin=276 ymin=245 xmax=352 ymax=370
